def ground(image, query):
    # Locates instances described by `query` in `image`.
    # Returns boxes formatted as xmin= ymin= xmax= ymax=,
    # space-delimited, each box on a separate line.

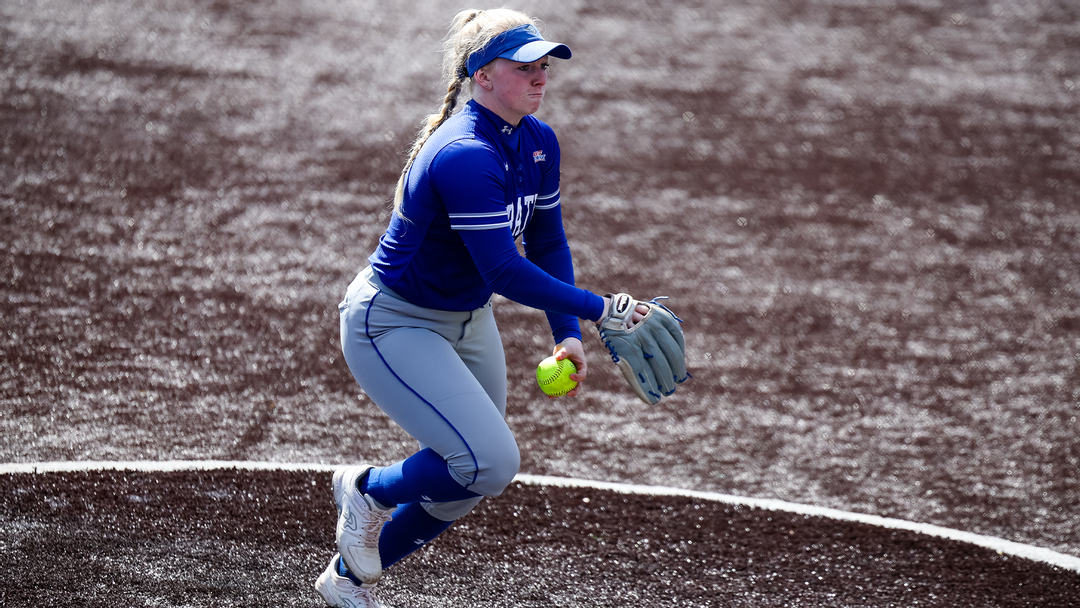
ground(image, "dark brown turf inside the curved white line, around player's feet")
xmin=0 ymin=470 xmax=1080 ymax=608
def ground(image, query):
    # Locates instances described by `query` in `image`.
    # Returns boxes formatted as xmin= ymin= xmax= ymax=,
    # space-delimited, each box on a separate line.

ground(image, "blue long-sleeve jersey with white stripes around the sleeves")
xmin=368 ymin=102 xmax=604 ymax=342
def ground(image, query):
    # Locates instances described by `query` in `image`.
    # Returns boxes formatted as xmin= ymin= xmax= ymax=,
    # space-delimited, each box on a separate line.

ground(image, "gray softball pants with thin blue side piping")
xmin=339 ymin=268 xmax=521 ymax=522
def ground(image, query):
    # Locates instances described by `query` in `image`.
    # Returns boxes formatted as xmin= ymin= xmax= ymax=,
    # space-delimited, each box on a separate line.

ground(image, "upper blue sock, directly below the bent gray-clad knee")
xmin=360 ymin=448 xmax=480 ymax=508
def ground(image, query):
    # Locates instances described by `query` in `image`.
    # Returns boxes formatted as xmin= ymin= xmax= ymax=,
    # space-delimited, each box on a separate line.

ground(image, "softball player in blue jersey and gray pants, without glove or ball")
xmin=315 ymin=9 xmax=639 ymax=606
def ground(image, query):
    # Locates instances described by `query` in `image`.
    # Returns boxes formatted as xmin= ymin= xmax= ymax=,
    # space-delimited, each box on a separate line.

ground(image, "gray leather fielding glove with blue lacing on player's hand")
xmin=596 ymin=294 xmax=690 ymax=405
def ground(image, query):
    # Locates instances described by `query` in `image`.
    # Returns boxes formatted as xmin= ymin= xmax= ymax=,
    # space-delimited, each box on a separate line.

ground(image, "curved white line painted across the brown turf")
xmin=0 ymin=460 xmax=1080 ymax=572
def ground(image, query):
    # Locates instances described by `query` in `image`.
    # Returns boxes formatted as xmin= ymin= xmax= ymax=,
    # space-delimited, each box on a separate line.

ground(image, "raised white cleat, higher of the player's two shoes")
xmin=334 ymin=465 xmax=393 ymax=584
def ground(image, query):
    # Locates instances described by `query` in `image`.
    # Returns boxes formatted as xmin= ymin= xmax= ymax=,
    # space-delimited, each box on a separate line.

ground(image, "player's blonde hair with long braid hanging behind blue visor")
xmin=394 ymin=9 xmax=537 ymax=217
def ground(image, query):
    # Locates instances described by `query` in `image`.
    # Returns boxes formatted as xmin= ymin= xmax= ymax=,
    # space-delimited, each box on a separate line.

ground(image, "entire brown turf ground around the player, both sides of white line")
xmin=0 ymin=0 xmax=1080 ymax=606
